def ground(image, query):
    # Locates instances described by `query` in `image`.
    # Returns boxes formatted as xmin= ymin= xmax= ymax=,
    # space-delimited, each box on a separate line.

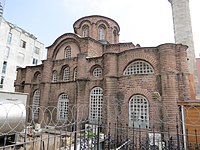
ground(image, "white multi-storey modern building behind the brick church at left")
xmin=0 ymin=18 xmax=44 ymax=92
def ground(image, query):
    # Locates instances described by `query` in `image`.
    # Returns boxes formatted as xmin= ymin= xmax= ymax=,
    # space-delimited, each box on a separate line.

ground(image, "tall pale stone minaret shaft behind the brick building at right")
xmin=169 ymin=0 xmax=200 ymax=99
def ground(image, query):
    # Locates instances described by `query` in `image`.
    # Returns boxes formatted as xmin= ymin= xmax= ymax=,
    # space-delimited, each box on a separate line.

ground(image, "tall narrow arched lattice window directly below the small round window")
xmin=89 ymin=87 xmax=103 ymax=124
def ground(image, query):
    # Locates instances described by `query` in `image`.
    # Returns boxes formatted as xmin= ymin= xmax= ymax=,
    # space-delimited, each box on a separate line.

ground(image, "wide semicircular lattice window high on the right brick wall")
xmin=124 ymin=60 xmax=154 ymax=76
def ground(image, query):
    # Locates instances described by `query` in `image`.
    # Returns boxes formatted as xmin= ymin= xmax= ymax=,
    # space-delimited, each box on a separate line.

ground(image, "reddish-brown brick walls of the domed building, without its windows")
xmin=15 ymin=16 xmax=191 ymax=135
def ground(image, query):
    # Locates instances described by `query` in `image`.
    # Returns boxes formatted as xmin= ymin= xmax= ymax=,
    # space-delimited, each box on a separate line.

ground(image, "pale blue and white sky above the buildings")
xmin=3 ymin=0 xmax=200 ymax=57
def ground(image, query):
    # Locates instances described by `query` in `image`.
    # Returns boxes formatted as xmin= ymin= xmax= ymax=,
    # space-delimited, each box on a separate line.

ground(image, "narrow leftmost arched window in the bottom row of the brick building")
xmin=32 ymin=90 xmax=40 ymax=119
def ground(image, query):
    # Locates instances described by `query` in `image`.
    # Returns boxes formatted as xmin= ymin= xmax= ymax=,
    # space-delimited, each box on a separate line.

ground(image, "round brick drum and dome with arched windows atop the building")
xmin=73 ymin=15 xmax=120 ymax=44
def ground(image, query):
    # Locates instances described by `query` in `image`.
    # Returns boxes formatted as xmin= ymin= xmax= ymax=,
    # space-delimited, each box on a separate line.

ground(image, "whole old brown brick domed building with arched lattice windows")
xmin=15 ymin=15 xmax=191 ymax=135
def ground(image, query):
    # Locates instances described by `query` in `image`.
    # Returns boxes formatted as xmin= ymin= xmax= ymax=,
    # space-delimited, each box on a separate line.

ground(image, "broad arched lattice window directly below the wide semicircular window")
xmin=129 ymin=95 xmax=149 ymax=128
